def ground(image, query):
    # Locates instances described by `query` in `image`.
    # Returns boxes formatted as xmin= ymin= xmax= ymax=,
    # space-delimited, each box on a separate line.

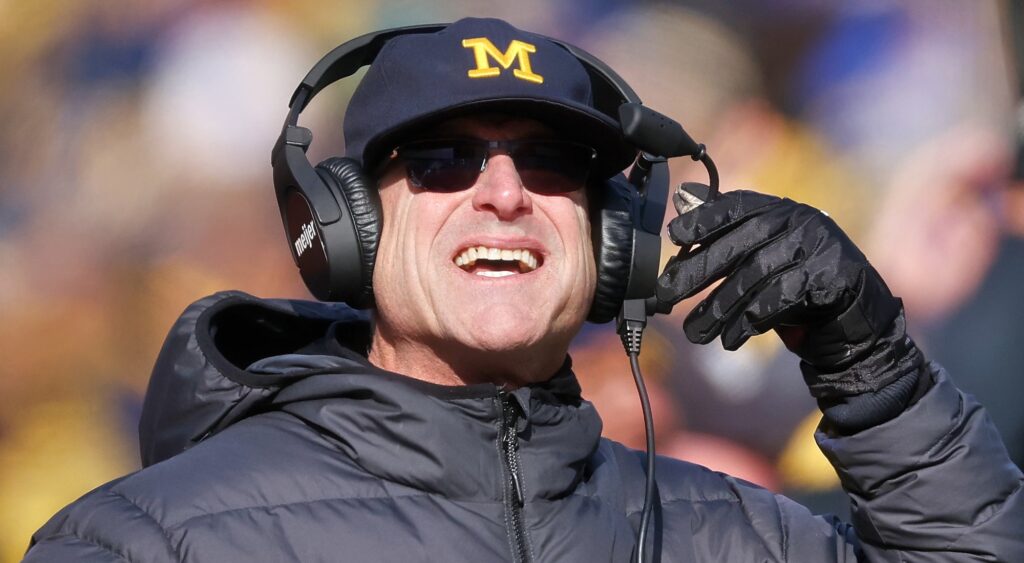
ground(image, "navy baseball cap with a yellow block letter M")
xmin=344 ymin=17 xmax=637 ymax=177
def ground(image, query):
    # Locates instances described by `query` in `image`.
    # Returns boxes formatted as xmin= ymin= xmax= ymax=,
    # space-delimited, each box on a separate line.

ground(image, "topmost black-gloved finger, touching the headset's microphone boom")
xmin=669 ymin=189 xmax=793 ymax=246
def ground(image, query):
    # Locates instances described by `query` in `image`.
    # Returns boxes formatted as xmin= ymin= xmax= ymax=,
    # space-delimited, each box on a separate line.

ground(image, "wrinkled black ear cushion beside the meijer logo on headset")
xmin=316 ymin=157 xmax=382 ymax=308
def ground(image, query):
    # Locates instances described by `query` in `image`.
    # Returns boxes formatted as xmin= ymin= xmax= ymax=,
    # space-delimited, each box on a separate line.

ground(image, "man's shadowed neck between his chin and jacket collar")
xmin=369 ymin=326 xmax=568 ymax=388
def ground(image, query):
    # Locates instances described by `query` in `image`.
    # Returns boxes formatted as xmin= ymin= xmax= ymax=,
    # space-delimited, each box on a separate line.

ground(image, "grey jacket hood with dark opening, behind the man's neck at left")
xmin=139 ymin=291 xmax=370 ymax=467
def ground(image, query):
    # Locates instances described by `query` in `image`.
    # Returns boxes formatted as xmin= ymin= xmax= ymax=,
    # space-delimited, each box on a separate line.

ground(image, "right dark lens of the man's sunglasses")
xmin=512 ymin=141 xmax=595 ymax=193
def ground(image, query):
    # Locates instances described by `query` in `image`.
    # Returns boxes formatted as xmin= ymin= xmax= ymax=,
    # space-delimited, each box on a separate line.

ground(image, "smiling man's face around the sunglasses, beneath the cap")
xmin=373 ymin=117 xmax=596 ymax=368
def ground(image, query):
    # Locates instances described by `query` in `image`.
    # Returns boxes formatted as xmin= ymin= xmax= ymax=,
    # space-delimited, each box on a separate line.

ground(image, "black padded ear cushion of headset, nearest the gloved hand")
xmin=587 ymin=202 xmax=633 ymax=322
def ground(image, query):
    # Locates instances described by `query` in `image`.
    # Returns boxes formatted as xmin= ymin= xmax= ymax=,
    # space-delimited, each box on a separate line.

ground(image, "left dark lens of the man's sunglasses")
xmin=399 ymin=143 xmax=486 ymax=191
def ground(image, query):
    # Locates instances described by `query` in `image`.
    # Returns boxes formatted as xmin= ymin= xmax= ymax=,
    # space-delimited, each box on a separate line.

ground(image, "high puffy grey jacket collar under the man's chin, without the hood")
xmin=263 ymin=339 xmax=601 ymax=502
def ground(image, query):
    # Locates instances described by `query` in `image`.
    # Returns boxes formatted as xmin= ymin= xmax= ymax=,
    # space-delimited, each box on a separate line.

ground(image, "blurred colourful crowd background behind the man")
xmin=0 ymin=0 xmax=1024 ymax=561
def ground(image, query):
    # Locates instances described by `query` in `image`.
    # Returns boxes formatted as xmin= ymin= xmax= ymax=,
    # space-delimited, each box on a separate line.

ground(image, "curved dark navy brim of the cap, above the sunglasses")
xmin=362 ymin=97 xmax=637 ymax=178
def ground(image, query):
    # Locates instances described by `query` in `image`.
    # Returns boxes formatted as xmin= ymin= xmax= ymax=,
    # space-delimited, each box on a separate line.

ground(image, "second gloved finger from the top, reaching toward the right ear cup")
xmin=655 ymin=202 xmax=802 ymax=304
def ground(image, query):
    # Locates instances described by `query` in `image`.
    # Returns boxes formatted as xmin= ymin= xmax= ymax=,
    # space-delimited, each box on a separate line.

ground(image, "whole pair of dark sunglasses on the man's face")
xmin=395 ymin=138 xmax=597 ymax=194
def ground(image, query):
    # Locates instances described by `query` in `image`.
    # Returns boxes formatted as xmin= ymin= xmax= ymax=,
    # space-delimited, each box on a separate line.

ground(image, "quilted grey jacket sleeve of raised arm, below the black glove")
xmin=815 ymin=363 xmax=1024 ymax=562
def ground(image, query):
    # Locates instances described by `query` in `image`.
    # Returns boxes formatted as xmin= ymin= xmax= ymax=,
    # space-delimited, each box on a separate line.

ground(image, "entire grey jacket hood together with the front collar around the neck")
xmin=139 ymin=292 xmax=601 ymax=497
